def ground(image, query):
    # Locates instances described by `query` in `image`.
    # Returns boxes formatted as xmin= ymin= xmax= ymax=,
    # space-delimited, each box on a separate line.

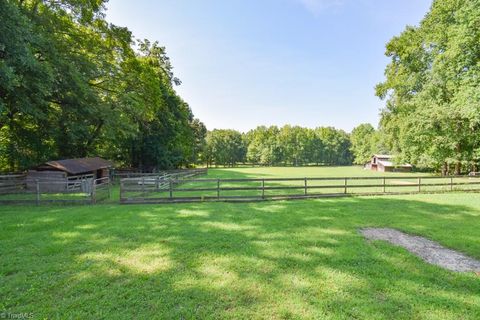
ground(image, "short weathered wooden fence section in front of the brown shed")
xmin=0 ymin=174 xmax=111 ymax=205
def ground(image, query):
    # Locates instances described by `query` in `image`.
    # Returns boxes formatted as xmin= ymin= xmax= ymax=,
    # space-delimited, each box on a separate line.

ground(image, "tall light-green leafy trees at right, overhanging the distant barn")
xmin=377 ymin=0 xmax=480 ymax=174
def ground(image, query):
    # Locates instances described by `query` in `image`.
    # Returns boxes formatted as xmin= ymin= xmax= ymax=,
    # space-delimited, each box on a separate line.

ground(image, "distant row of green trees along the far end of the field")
xmin=203 ymin=125 xmax=353 ymax=166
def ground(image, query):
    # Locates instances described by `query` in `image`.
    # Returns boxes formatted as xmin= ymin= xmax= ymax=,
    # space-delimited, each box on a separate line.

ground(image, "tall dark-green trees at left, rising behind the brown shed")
xmin=0 ymin=0 xmax=206 ymax=171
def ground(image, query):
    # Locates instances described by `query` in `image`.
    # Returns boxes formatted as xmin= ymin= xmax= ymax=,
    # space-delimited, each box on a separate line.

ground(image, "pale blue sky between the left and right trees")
xmin=107 ymin=0 xmax=431 ymax=131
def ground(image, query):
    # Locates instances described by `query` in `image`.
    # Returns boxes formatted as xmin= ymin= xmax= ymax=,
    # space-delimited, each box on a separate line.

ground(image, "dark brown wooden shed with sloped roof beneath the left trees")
xmin=27 ymin=157 xmax=113 ymax=191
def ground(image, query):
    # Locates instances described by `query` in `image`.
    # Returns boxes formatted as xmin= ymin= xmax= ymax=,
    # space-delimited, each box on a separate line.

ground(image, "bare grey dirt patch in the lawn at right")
xmin=360 ymin=228 xmax=480 ymax=272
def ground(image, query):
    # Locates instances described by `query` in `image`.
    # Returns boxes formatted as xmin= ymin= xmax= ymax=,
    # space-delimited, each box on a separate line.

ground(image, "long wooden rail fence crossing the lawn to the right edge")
xmin=120 ymin=176 xmax=480 ymax=204
